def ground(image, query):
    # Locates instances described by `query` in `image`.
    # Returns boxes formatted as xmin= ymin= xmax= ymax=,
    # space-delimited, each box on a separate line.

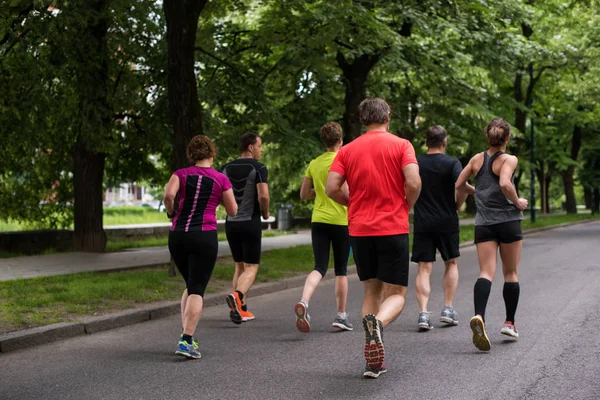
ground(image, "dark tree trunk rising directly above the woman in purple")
xmin=163 ymin=0 xmax=207 ymax=170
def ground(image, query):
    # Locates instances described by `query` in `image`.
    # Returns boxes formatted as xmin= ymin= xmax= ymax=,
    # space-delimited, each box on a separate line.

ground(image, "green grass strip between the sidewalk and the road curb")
xmin=0 ymin=215 xmax=598 ymax=333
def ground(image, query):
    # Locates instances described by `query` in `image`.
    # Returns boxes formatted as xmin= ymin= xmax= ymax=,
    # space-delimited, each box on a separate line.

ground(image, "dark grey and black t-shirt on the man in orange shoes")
xmin=219 ymin=158 xmax=269 ymax=221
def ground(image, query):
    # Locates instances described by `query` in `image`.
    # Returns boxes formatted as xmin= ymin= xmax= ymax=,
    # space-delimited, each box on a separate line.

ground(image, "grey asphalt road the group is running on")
xmin=0 ymin=223 xmax=600 ymax=400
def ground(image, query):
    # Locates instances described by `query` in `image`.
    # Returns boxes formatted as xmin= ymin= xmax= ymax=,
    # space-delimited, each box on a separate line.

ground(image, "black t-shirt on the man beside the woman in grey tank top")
xmin=414 ymin=154 xmax=462 ymax=233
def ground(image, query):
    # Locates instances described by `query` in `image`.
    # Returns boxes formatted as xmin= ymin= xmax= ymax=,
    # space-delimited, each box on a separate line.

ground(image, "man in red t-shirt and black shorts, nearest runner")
xmin=326 ymin=98 xmax=421 ymax=378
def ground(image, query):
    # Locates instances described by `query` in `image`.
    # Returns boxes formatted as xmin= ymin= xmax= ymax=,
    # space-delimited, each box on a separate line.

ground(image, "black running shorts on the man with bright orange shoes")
xmin=225 ymin=217 xmax=262 ymax=264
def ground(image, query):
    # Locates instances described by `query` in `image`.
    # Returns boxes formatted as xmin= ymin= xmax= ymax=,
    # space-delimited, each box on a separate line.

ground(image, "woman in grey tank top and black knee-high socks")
xmin=456 ymin=118 xmax=527 ymax=351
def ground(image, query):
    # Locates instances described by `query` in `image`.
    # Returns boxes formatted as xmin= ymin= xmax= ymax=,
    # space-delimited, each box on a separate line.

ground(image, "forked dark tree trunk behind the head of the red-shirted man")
xmin=336 ymin=52 xmax=380 ymax=143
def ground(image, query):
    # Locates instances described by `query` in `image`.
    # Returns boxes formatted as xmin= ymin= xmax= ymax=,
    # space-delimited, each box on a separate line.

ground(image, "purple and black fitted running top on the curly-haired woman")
xmin=171 ymin=166 xmax=231 ymax=232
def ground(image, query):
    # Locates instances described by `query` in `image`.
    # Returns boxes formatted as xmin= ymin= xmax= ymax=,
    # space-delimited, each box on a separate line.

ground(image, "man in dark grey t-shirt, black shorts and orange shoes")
xmin=220 ymin=133 xmax=269 ymax=324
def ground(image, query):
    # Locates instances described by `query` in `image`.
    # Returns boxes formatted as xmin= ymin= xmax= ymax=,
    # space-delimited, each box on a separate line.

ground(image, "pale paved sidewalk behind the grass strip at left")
xmin=0 ymin=231 xmax=311 ymax=281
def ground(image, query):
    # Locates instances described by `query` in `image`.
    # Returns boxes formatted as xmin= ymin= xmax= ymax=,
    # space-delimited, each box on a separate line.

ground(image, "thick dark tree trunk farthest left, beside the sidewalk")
xmin=73 ymin=0 xmax=112 ymax=252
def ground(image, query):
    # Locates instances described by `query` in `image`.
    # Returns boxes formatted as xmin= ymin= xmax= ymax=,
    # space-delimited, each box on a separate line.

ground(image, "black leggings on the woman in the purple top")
xmin=169 ymin=231 xmax=219 ymax=297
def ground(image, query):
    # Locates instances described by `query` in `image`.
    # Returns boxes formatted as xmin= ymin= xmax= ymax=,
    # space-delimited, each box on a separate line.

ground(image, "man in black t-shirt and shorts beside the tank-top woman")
xmin=411 ymin=125 xmax=467 ymax=330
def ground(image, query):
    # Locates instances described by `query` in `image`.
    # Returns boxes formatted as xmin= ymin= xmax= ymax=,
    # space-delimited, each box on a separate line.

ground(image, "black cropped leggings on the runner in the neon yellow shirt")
xmin=311 ymin=222 xmax=350 ymax=276
